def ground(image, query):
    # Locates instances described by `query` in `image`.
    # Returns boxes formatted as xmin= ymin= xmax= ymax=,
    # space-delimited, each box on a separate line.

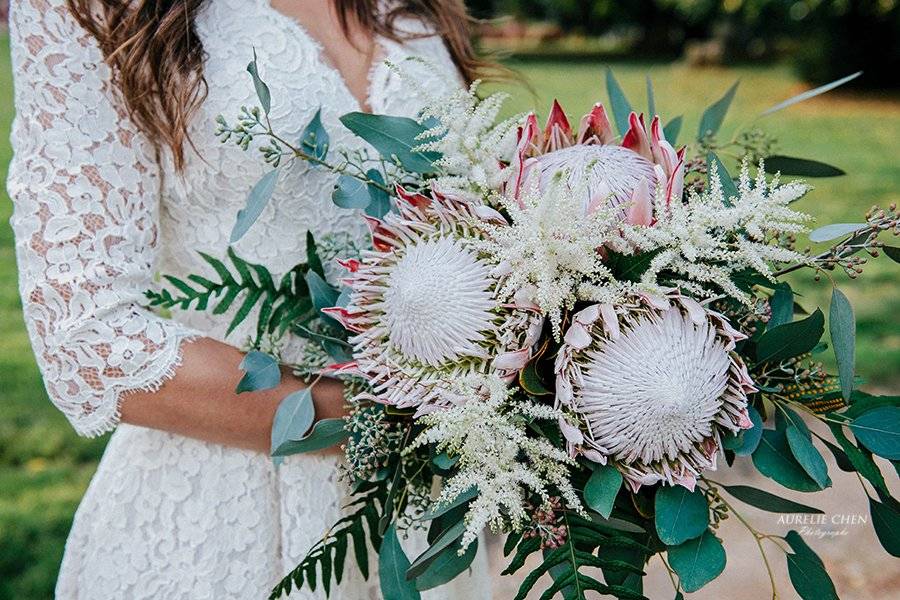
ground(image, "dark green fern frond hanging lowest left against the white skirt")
xmin=269 ymin=481 xmax=387 ymax=600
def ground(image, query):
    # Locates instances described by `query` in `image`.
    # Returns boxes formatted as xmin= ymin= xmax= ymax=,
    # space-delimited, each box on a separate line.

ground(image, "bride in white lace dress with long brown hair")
xmin=9 ymin=0 xmax=490 ymax=600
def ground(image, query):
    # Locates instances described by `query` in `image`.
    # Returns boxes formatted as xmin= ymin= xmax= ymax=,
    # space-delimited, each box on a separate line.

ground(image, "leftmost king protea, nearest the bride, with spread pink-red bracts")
xmin=325 ymin=188 xmax=542 ymax=412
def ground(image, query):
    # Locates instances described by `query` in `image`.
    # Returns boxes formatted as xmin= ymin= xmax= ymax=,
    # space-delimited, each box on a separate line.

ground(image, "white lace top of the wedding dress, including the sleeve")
xmin=8 ymin=0 xmax=459 ymax=435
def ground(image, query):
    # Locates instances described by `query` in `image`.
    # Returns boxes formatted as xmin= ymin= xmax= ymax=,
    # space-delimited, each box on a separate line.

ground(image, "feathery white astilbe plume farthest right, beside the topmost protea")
xmin=622 ymin=163 xmax=811 ymax=303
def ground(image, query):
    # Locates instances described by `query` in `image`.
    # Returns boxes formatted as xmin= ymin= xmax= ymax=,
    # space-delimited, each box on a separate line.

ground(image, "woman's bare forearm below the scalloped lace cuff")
xmin=121 ymin=338 xmax=344 ymax=453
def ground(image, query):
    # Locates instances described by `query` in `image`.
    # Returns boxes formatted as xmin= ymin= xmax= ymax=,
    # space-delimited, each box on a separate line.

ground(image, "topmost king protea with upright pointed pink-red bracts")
xmin=507 ymin=101 xmax=684 ymax=225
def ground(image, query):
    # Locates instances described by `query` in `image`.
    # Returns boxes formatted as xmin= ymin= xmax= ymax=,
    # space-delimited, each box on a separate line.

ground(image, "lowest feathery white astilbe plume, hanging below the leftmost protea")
xmin=406 ymin=375 xmax=581 ymax=551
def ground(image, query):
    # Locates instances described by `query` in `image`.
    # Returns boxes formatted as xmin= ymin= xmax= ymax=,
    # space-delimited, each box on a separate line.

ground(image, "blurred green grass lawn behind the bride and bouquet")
xmin=0 ymin=34 xmax=900 ymax=599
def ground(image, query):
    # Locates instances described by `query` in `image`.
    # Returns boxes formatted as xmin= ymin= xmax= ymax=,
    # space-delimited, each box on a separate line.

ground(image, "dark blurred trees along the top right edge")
xmin=468 ymin=0 xmax=900 ymax=89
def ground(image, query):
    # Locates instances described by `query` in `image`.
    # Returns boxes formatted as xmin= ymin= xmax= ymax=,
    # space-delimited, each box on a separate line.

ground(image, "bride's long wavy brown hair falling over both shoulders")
xmin=67 ymin=0 xmax=486 ymax=169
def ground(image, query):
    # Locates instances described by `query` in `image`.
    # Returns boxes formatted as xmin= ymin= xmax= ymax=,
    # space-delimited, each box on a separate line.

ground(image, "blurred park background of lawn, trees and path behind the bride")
xmin=0 ymin=0 xmax=900 ymax=600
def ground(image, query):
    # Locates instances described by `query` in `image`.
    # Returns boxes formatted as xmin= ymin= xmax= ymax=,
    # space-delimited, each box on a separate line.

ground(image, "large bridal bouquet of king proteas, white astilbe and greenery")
xmin=150 ymin=61 xmax=900 ymax=600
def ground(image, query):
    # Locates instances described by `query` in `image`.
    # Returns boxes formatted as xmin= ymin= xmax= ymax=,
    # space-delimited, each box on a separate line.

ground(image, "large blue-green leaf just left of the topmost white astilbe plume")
xmin=341 ymin=112 xmax=441 ymax=174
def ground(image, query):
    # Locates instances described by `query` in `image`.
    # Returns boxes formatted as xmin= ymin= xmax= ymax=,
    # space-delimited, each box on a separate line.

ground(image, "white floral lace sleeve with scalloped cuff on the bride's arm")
xmin=8 ymin=0 xmax=198 ymax=435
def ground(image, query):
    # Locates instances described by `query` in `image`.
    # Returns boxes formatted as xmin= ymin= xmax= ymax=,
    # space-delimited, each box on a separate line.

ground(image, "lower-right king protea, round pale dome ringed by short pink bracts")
xmin=556 ymin=295 xmax=756 ymax=491
